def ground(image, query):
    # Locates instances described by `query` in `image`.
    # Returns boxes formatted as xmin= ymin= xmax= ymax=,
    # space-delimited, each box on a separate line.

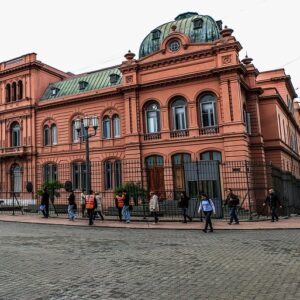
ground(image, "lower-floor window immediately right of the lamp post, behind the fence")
xmin=104 ymin=160 xmax=122 ymax=190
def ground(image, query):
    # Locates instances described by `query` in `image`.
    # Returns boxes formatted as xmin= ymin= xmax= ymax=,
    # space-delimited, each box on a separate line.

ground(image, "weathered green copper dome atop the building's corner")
xmin=139 ymin=12 xmax=222 ymax=58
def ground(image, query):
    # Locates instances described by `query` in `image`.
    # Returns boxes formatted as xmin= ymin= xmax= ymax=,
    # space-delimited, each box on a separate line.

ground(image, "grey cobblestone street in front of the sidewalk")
xmin=0 ymin=222 xmax=300 ymax=300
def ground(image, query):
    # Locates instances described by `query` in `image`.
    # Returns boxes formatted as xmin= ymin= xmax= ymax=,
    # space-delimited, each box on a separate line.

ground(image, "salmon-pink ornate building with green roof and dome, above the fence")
xmin=0 ymin=13 xmax=300 ymax=212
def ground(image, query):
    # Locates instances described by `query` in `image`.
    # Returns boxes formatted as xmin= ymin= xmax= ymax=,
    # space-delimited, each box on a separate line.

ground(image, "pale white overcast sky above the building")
xmin=0 ymin=0 xmax=300 ymax=94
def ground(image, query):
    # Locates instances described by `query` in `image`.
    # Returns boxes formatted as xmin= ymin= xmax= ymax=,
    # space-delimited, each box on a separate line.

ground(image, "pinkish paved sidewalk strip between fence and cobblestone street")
xmin=0 ymin=214 xmax=300 ymax=230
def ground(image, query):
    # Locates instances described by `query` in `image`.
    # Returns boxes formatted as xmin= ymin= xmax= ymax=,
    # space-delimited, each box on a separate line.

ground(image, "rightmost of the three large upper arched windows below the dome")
xmin=199 ymin=94 xmax=217 ymax=128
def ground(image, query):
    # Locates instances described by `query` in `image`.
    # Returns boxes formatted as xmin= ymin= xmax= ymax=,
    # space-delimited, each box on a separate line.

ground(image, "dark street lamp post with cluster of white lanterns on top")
xmin=75 ymin=116 xmax=98 ymax=194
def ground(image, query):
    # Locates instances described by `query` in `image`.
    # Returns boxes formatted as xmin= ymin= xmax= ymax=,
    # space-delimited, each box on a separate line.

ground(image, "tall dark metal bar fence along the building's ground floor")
xmin=0 ymin=156 xmax=300 ymax=220
